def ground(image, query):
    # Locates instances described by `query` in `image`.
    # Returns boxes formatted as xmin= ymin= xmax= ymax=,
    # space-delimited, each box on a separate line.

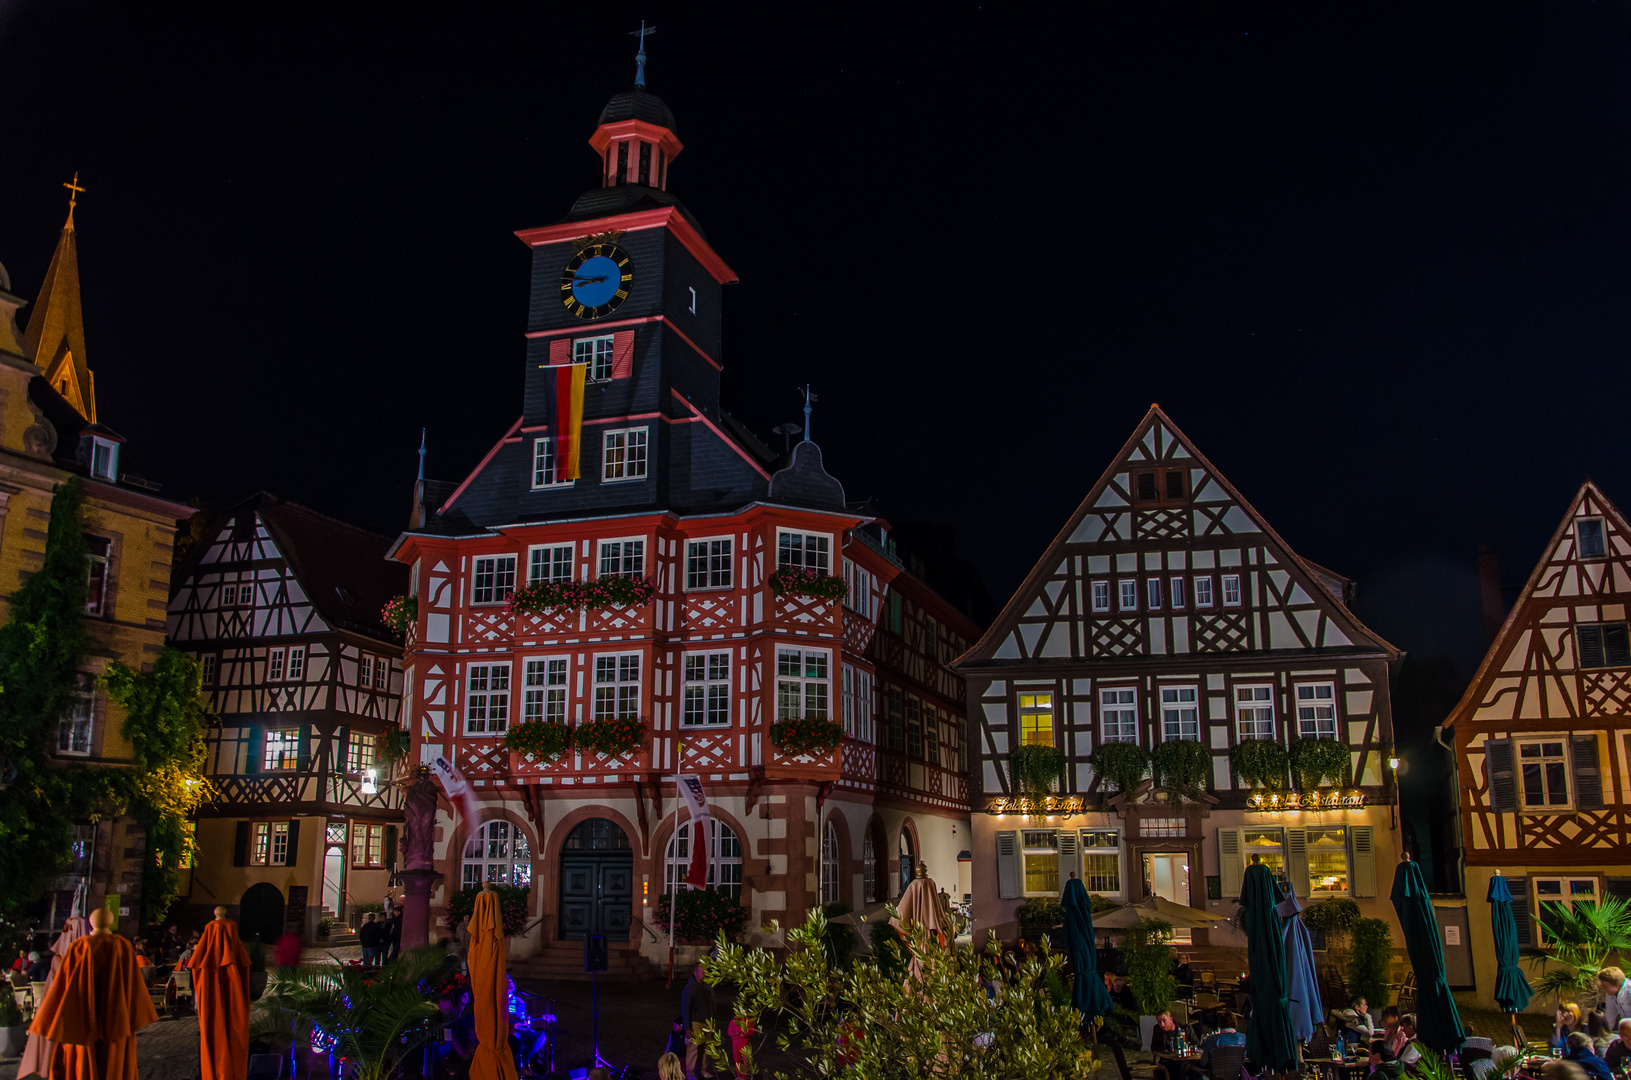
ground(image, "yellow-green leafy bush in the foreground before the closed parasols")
xmin=703 ymin=912 xmax=1098 ymax=1080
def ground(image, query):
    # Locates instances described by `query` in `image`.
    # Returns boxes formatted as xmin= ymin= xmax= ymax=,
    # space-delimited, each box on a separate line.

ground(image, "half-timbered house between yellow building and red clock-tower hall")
xmin=170 ymin=493 xmax=408 ymax=940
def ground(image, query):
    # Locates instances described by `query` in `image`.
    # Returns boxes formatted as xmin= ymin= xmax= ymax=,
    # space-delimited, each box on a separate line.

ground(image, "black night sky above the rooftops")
xmin=0 ymin=0 xmax=1631 ymax=681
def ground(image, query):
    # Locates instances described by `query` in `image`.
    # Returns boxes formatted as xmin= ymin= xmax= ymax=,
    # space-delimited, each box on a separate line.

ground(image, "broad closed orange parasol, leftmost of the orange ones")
xmin=28 ymin=907 xmax=158 ymax=1080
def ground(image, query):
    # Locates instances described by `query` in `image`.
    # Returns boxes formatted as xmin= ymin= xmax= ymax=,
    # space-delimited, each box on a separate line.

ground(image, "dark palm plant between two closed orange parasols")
xmin=250 ymin=948 xmax=457 ymax=1080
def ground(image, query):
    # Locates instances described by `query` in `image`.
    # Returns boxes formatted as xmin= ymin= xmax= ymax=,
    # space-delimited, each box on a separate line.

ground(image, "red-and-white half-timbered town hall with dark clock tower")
xmin=393 ymin=61 xmax=972 ymax=974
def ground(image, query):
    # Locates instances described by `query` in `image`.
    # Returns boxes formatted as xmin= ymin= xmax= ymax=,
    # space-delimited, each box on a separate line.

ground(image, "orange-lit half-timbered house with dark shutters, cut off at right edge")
xmin=1447 ymin=481 xmax=1631 ymax=1008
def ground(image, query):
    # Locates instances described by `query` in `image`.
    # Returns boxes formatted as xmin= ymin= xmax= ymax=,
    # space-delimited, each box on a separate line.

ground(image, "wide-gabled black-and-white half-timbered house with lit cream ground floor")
xmin=957 ymin=406 xmax=1399 ymax=943
